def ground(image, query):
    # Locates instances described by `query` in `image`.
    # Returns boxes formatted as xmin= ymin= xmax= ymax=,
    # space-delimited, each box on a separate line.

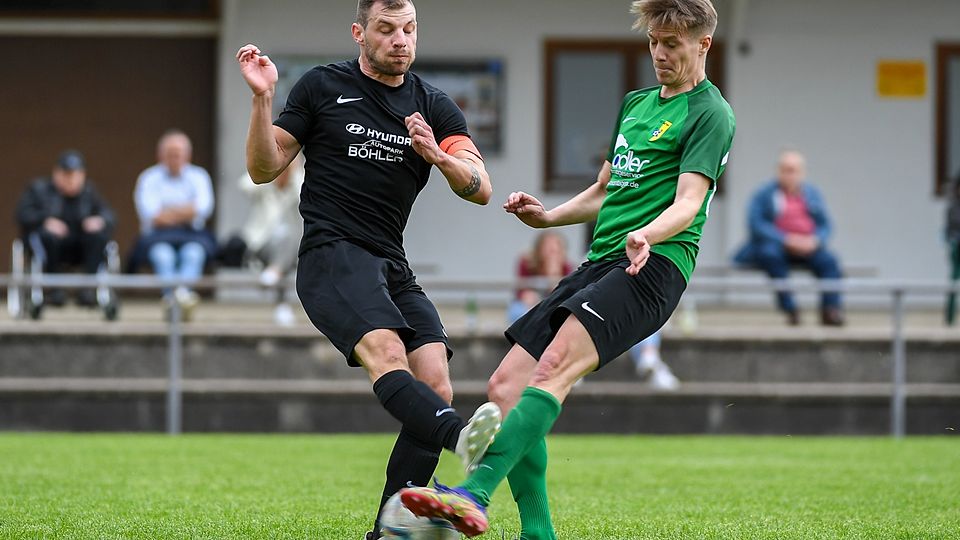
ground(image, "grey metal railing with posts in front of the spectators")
xmin=0 ymin=274 xmax=960 ymax=438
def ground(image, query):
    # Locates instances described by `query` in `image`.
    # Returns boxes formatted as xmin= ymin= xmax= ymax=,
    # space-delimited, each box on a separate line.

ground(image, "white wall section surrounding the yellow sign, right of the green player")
xmin=723 ymin=0 xmax=960 ymax=279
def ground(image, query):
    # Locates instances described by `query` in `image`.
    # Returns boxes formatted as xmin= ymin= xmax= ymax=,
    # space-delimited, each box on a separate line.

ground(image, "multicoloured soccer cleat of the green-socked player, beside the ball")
xmin=400 ymin=479 xmax=490 ymax=538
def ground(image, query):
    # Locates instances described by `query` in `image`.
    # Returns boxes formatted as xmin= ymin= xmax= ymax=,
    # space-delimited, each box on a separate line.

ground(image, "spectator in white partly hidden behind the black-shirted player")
xmin=223 ymin=156 xmax=304 ymax=326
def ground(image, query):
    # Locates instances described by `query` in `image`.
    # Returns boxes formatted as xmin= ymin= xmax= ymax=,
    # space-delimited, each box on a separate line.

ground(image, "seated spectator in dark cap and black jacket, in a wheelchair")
xmin=17 ymin=150 xmax=116 ymax=307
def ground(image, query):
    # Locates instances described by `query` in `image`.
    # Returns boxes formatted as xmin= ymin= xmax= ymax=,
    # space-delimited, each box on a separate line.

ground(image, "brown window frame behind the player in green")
xmin=543 ymin=38 xmax=726 ymax=193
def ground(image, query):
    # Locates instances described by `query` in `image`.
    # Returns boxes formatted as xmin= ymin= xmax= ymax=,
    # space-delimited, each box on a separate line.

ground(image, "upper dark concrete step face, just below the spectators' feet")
xmin=0 ymin=336 xmax=960 ymax=387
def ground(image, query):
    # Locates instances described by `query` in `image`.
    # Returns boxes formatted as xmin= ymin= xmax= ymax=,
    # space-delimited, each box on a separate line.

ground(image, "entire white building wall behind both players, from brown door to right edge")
xmin=218 ymin=0 xmax=960 ymax=279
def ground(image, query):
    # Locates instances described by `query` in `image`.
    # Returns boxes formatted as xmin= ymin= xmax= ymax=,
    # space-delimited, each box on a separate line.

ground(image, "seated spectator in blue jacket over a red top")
xmin=734 ymin=150 xmax=844 ymax=326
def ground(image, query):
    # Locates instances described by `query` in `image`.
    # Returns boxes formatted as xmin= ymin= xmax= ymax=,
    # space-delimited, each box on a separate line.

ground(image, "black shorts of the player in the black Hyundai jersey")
xmin=297 ymin=241 xmax=453 ymax=366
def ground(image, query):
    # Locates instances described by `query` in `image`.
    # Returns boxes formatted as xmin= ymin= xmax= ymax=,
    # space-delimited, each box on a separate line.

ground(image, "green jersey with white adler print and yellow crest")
xmin=587 ymin=80 xmax=736 ymax=281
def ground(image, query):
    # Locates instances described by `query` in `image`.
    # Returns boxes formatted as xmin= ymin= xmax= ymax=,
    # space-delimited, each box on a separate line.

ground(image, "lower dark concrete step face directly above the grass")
xmin=0 ymin=379 xmax=960 ymax=435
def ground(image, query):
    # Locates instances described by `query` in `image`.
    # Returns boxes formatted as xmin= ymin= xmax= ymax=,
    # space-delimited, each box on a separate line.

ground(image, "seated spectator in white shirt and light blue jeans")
xmin=134 ymin=130 xmax=216 ymax=320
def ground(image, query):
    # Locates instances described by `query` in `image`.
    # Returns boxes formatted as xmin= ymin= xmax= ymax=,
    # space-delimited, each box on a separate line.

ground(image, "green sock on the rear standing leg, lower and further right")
xmin=507 ymin=439 xmax=557 ymax=540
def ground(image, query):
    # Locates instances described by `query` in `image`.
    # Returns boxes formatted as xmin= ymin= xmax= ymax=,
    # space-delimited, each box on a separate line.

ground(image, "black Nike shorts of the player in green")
xmin=504 ymin=253 xmax=687 ymax=369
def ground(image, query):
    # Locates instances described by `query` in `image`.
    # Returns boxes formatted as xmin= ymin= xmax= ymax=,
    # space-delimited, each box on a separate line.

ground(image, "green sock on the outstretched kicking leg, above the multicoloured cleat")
xmin=460 ymin=386 xmax=560 ymax=506
